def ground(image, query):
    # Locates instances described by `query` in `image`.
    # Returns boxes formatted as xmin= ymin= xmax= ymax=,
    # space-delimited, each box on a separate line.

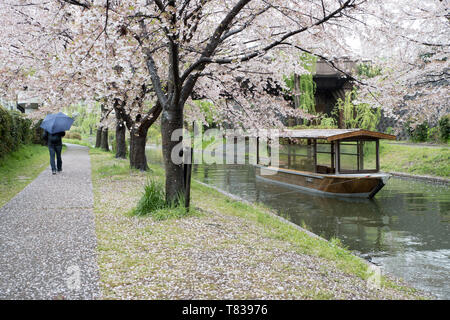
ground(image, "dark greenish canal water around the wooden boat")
xmin=148 ymin=148 xmax=450 ymax=299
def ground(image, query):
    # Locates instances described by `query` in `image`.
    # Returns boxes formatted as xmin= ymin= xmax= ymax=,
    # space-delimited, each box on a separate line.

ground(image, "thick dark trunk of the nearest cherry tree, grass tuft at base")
xmin=161 ymin=108 xmax=185 ymax=202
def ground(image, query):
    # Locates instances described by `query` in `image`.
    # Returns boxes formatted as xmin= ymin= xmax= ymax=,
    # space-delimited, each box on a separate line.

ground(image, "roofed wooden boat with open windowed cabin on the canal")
xmin=256 ymin=129 xmax=396 ymax=198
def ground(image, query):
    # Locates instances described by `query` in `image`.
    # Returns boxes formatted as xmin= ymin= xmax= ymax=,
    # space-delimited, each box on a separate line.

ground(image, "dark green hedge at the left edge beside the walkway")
xmin=0 ymin=106 xmax=38 ymax=158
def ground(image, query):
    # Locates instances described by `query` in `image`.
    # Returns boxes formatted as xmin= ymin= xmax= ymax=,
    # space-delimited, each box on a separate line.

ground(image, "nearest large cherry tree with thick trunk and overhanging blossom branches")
xmin=121 ymin=0 xmax=364 ymax=201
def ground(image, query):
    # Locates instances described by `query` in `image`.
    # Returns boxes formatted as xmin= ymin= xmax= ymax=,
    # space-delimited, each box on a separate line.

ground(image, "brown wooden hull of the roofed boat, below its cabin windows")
xmin=256 ymin=166 xmax=390 ymax=198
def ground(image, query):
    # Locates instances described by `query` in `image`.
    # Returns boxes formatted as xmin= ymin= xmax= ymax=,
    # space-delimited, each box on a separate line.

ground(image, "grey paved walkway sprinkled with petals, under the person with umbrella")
xmin=0 ymin=145 xmax=99 ymax=299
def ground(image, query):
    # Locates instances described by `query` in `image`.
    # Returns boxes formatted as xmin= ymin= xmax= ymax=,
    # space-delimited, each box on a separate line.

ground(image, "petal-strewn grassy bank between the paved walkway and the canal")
xmin=87 ymin=150 xmax=423 ymax=299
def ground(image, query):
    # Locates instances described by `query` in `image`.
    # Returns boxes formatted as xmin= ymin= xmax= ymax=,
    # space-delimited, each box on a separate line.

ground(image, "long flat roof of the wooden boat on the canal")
xmin=279 ymin=129 xmax=397 ymax=141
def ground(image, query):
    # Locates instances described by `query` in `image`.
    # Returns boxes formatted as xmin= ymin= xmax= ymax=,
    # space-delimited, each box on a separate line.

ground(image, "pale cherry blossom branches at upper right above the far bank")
xmin=346 ymin=0 xmax=450 ymax=132
